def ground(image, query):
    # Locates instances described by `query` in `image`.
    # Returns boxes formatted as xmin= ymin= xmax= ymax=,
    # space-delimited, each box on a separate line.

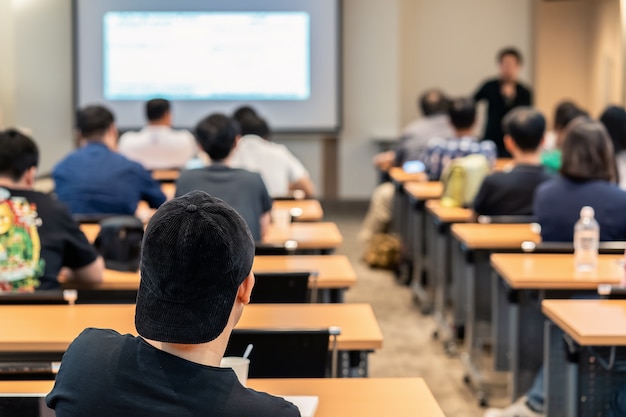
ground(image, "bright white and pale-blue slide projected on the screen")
xmin=103 ymin=12 xmax=311 ymax=100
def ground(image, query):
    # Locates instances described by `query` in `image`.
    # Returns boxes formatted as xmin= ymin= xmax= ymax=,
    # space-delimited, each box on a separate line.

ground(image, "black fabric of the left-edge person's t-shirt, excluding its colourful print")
xmin=2 ymin=189 xmax=98 ymax=290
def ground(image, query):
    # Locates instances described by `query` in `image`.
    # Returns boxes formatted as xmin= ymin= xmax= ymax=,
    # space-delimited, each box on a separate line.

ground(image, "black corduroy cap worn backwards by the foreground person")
xmin=135 ymin=191 xmax=255 ymax=344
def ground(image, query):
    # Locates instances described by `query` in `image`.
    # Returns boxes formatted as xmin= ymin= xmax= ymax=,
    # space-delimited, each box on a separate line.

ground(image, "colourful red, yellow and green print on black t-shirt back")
xmin=0 ymin=188 xmax=44 ymax=292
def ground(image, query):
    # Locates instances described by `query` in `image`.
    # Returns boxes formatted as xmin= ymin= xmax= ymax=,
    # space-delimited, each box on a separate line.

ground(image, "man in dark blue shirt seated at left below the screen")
xmin=52 ymin=106 xmax=165 ymax=215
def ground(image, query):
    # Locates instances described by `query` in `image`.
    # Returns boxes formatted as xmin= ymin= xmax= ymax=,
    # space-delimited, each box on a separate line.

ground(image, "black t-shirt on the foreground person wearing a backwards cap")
xmin=46 ymin=329 xmax=300 ymax=417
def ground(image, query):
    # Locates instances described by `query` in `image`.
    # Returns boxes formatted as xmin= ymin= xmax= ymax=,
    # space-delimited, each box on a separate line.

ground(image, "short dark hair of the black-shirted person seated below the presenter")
xmin=502 ymin=107 xmax=546 ymax=152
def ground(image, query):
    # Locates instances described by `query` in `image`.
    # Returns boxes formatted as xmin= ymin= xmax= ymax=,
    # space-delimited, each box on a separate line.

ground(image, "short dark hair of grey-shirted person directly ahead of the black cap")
xmin=195 ymin=113 xmax=240 ymax=162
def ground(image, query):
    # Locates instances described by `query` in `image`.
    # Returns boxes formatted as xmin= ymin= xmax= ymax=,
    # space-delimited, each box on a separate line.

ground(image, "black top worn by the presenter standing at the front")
xmin=474 ymin=80 xmax=533 ymax=158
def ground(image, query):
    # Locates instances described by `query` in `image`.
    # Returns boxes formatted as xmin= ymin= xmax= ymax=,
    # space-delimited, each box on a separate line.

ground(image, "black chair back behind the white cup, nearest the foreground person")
xmin=225 ymin=327 xmax=341 ymax=378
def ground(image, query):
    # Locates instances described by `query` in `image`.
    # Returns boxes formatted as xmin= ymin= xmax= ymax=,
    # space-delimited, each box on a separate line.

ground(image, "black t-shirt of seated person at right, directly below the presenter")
xmin=474 ymin=164 xmax=551 ymax=216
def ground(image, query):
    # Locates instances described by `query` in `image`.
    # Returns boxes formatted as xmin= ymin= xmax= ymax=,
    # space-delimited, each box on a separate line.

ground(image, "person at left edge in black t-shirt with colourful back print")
xmin=0 ymin=130 xmax=104 ymax=291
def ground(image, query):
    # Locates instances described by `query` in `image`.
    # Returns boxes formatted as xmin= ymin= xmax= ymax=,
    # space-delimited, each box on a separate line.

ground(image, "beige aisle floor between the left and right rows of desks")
xmin=325 ymin=204 xmax=506 ymax=417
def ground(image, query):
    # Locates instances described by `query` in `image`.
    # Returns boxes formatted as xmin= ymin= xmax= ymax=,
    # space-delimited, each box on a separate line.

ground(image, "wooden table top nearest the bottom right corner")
xmin=541 ymin=300 xmax=626 ymax=346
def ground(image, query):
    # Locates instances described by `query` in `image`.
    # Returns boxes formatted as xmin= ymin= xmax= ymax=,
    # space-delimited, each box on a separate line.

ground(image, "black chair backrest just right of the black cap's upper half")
xmin=250 ymin=272 xmax=311 ymax=304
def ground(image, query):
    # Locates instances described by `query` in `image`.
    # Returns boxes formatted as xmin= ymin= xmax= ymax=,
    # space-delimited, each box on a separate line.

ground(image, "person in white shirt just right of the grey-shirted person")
xmin=231 ymin=116 xmax=315 ymax=197
